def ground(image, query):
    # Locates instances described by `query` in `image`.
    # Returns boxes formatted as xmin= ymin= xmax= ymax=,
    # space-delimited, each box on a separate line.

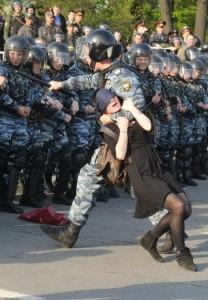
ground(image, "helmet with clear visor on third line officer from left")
xmin=47 ymin=42 xmax=70 ymax=66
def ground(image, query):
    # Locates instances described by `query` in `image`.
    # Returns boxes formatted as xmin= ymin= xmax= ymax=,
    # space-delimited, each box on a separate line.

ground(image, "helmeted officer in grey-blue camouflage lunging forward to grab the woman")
xmin=39 ymin=29 xmax=145 ymax=248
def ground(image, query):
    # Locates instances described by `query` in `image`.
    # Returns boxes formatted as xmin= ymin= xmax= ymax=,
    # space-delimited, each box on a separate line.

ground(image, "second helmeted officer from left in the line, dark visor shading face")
xmin=21 ymin=46 xmax=49 ymax=207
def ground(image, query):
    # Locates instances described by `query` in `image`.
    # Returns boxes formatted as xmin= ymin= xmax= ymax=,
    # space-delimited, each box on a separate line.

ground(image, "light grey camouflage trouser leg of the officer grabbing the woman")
xmin=69 ymin=148 xmax=103 ymax=226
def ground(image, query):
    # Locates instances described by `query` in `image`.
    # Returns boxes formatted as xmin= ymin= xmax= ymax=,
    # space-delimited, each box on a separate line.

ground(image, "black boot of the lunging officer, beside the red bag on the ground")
xmin=40 ymin=222 xmax=81 ymax=248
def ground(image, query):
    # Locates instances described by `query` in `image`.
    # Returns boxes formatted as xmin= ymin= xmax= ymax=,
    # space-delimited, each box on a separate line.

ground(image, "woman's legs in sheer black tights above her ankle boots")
xmin=152 ymin=194 xmax=191 ymax=250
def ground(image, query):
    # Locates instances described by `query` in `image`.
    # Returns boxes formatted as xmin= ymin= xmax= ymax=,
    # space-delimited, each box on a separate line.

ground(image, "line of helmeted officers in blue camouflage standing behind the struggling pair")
xmin=0 ymin=32 xmax=208 ymax=213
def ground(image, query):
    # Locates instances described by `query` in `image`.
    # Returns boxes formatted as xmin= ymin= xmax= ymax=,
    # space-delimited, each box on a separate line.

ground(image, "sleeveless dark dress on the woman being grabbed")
xmin=104 ymin=123 xmax=184 ymax=218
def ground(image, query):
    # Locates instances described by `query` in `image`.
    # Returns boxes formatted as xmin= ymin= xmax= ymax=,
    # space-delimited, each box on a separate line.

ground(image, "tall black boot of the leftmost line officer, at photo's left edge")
xmin=0 ymin=168 xmax=23 ymax=214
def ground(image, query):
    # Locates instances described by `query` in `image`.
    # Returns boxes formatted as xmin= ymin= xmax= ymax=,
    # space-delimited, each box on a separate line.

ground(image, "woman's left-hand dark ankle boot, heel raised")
xmin=140 ymin=231 xmax=165 ymax=262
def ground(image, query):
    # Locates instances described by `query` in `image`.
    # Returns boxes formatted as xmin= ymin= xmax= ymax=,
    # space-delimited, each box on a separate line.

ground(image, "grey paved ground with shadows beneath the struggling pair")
xmin=0 ymin=181 xmax=208 ymax=300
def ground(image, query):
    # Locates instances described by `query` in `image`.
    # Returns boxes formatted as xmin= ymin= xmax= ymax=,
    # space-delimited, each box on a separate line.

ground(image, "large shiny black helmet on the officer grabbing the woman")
xmin=86 ymin=29 xmax=117 ymax=62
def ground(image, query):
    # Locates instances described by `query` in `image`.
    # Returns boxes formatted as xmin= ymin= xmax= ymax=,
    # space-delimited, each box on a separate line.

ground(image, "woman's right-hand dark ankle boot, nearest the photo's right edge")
xmin=176 ymin=247 xmax=197 ymax=272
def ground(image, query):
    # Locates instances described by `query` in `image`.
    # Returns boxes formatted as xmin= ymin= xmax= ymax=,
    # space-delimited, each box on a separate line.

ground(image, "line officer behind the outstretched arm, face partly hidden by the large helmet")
xmin=67 ymin=40 xmax=100 ymax=200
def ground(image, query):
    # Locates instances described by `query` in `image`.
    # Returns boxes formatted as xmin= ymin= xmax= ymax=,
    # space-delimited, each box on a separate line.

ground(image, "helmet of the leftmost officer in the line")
xmin=5 ymin=35 xmax=30 ymax=64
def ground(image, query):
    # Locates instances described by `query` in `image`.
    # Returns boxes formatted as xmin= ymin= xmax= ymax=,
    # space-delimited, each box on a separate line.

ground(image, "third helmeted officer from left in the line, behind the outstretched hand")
xmin=45 ymin=42 xmax=77 ymax=204
